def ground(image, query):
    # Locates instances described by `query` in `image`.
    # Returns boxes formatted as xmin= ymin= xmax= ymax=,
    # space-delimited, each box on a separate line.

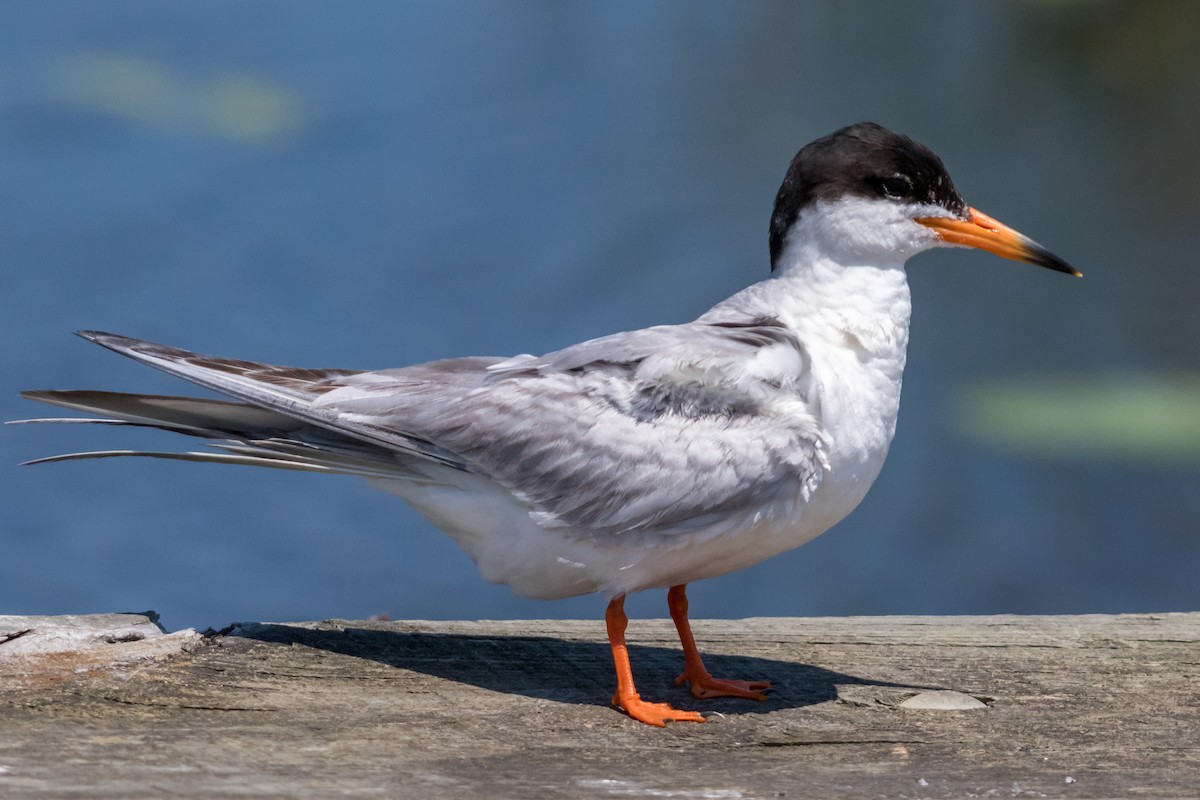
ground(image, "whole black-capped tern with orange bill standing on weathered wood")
xmin=11 ymin=122 xmax=1080 ymax=727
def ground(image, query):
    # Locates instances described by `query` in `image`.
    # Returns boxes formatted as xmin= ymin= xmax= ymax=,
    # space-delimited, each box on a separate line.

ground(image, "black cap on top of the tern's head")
xmin=770 ymin=122 xmax=967 ymax=270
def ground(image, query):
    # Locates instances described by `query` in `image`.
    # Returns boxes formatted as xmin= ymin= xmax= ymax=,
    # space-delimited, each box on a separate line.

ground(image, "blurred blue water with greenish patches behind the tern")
xmin=0 ymin=0 xmax=1200 ymax=627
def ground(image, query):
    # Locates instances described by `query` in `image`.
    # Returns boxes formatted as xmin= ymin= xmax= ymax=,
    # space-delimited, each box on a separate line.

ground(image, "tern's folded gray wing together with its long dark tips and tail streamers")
xmin=21 ymin=319 xmax=827 ymax=530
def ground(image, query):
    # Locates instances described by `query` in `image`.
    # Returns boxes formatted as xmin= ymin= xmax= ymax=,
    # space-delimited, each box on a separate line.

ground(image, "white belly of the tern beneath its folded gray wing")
xmin=373 ymin=407 xmax=886 ymax=600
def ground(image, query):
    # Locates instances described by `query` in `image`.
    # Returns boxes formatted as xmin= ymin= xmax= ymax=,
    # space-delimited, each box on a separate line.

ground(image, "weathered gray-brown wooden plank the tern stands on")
xmin=0 ymin=613 xmax=1200 ymax=799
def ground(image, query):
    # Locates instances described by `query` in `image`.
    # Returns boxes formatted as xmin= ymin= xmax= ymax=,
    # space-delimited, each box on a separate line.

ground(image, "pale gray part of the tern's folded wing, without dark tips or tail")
xmin=314 ymin=319 xmax=826 ymax=530
